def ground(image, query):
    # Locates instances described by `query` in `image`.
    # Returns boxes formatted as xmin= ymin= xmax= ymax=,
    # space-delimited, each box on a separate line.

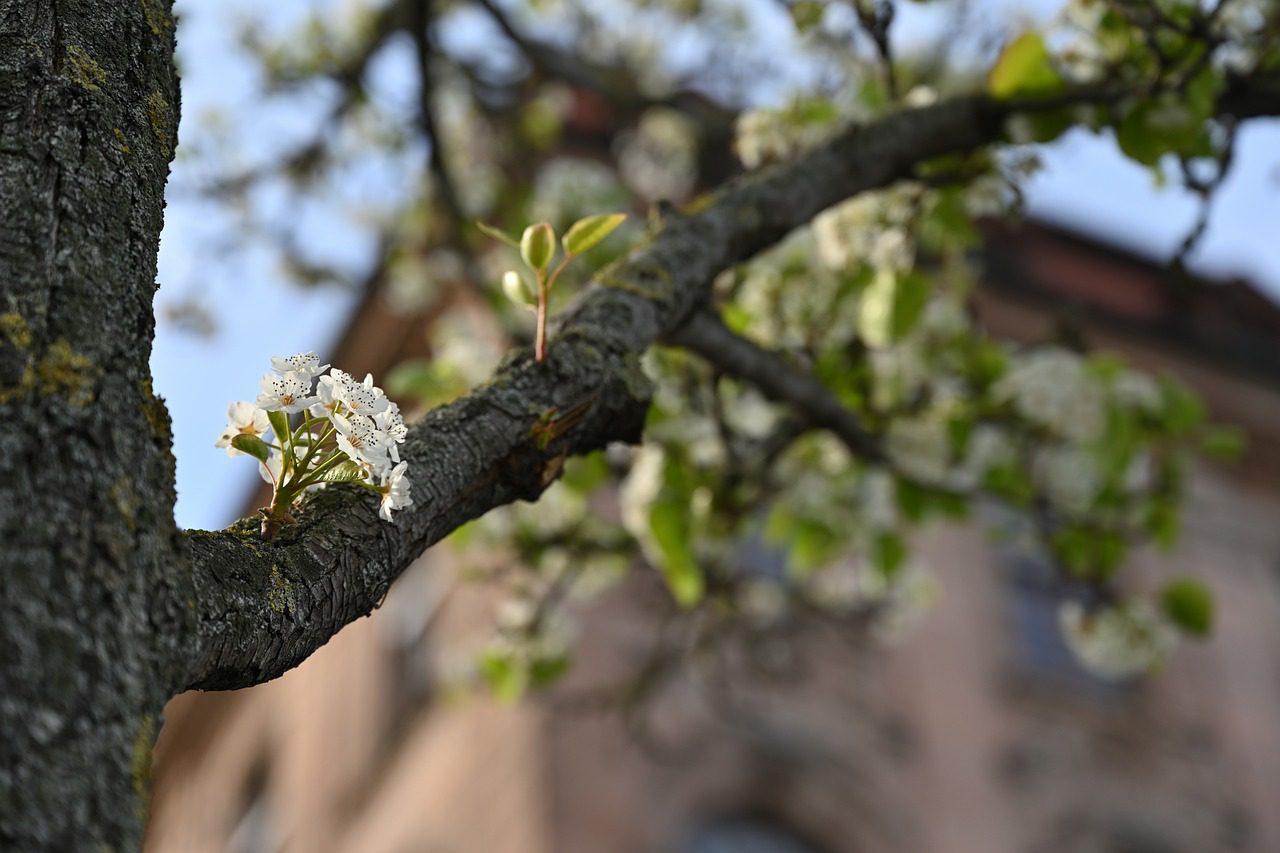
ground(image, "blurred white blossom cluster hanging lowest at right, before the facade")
xmin=1059 ymin=599 xmax=1178 ymax=679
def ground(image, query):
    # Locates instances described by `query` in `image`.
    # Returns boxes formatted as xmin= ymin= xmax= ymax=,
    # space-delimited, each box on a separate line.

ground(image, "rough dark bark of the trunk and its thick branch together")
xmin=0 ymin=0 xmax=1277 ymax=850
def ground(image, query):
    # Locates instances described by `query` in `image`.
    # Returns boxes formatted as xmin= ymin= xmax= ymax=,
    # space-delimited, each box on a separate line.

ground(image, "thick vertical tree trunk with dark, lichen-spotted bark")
xmin=0 ymin=0 xmax=185 ymax=850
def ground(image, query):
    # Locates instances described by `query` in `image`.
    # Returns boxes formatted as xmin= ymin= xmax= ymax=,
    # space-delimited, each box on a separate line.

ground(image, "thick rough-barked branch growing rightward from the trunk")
xmin=177 ymin=74 xmax=1276 ymax=688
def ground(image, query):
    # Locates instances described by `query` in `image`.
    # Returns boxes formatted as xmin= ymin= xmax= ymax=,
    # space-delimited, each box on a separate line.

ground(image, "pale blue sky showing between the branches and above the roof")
xmin=151 ymin=0 xmax=1280 ymax=528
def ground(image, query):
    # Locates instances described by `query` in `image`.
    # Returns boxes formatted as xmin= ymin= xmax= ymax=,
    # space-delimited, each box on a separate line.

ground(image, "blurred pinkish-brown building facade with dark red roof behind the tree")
xmin=147 ymin=224 xmax=1280 ymax=853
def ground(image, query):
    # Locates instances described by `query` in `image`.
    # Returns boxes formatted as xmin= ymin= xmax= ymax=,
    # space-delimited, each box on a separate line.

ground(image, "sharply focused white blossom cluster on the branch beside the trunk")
xmin=214 ymin=352 xmax=413 ymax=521
